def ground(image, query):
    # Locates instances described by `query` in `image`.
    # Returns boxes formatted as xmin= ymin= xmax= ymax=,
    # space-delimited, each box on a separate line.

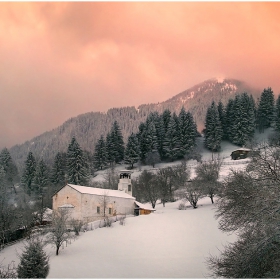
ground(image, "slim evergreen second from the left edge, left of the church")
xmin=21 ymin=152 xmax=36 ymax=195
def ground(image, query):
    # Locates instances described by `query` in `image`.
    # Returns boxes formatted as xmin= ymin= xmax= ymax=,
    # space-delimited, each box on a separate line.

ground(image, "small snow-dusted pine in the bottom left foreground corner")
xmin=17 ymin=240 xmax=50 ymax=279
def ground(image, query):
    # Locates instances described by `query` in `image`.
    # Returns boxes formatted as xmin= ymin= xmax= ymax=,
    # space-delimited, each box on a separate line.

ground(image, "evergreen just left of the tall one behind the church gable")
xmin=51 ymin=152 xmax=66 ymax=189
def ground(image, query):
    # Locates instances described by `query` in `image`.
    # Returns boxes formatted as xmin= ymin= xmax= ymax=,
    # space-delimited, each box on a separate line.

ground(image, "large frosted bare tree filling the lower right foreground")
xmin=208 ymin=145 xmax=280 ymax=278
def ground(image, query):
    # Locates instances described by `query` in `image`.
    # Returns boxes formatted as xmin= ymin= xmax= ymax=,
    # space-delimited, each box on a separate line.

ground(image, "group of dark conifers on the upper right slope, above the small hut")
xmin=204 ymin=88 xmax=280 ymax=152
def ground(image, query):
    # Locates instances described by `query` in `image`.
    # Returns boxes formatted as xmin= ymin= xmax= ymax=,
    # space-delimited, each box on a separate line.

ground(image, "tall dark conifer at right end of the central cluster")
xmin=178 ymin=107 xmax=197 ymax=157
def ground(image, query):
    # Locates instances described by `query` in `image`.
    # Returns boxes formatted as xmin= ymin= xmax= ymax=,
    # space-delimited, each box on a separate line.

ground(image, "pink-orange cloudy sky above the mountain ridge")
xmin=0 ymin=2 xmax=280 ymax=148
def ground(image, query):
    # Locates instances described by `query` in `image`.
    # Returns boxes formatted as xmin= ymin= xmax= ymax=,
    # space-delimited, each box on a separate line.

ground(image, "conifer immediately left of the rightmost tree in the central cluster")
xmin=163 ymin=114 xmax=180 ymax=161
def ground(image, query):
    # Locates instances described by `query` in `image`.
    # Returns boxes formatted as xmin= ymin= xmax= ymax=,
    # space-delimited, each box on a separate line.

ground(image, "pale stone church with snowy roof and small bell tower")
xmin=53 ymin=170 xmax=154 ymax=222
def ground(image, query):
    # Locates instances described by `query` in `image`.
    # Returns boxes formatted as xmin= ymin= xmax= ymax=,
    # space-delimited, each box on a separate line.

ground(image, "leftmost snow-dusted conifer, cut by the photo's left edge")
xmin=0 ymin=148 xmax=19 ymax=192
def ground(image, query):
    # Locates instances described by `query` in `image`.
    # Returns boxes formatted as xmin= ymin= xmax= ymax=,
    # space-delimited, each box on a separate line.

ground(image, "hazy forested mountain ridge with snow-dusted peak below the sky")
xmin=10 ymin=78 xmax=262 ymax=172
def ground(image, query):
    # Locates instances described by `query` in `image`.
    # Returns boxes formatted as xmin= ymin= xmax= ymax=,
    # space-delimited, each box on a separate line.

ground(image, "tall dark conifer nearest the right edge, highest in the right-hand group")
xmin=256 ymin=87 xmax=274 ymax=132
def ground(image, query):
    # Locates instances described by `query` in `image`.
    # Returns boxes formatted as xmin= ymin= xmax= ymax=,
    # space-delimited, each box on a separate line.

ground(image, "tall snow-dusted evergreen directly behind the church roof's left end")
xmin=67 ymin=137 xmax=89 ymax=185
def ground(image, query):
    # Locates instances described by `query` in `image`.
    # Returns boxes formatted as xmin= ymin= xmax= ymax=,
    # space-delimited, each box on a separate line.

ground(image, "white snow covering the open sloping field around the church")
xmin=0 ymin=133 xmax=274 ymax=278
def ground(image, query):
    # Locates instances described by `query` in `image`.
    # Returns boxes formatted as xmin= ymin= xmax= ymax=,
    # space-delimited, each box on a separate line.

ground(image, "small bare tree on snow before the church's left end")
xmin=47 ymin=209 xmax=71 ymax=255
